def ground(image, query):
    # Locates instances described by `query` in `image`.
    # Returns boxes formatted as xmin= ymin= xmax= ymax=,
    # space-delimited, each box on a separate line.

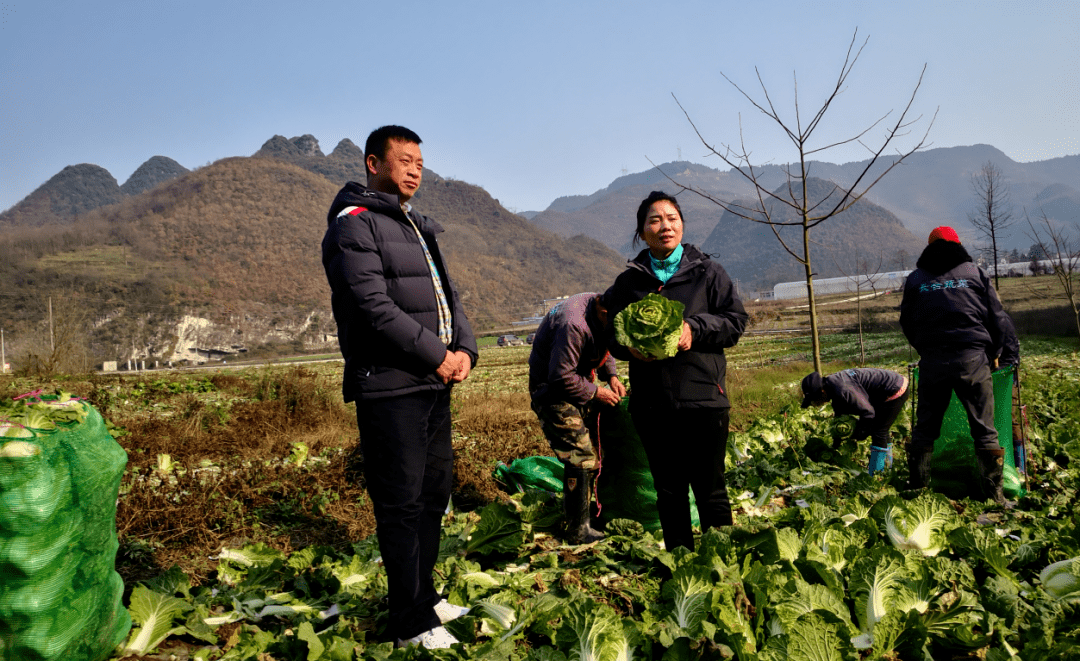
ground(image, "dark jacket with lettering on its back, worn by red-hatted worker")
xmin=900 ymin=241 xmax=1020 ymax=365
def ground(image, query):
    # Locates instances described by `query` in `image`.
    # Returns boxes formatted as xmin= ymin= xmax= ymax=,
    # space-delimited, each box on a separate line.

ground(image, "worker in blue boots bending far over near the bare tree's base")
xmin=802 ymin=368 xmax=907 ymax=475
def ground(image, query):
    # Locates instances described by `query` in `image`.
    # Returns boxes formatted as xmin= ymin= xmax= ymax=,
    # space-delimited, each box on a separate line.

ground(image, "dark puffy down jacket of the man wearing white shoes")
xmin=323 ymin=181 xmax=477 ymax=402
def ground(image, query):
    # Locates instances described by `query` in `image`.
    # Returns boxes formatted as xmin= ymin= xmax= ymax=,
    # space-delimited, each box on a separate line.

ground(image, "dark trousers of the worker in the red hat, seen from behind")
xmin=912 ymin=352 xmax=1001 ymax=450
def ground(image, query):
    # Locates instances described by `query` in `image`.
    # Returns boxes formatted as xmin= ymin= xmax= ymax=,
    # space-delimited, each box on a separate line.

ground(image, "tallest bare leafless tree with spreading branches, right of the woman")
xmin=665 ymin=30 xmax=936 ymax=372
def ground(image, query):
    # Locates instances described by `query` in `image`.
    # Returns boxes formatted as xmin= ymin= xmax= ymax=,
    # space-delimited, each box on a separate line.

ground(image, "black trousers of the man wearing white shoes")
xmin=356 ymin=388 xmax=454 ymax=638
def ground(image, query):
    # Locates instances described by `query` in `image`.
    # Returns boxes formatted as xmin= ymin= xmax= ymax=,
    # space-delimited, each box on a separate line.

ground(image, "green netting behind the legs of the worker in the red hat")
xmin=915 ymin=366 xmax=1025 ymax=498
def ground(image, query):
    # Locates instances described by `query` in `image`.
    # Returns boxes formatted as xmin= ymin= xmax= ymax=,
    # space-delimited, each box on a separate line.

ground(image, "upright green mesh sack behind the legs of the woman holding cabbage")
xmin=597 ymin=397 xmax=701 ymax=530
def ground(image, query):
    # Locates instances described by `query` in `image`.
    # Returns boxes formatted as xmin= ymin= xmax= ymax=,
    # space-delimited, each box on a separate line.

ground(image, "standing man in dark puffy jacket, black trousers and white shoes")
xmin=323 ymin=126 xmax=477 ymax=648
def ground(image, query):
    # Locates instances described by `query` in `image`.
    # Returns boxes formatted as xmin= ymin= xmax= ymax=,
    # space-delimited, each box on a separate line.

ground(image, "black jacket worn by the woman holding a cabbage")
xmin=607 ymin=244 xmax=747 ymax=408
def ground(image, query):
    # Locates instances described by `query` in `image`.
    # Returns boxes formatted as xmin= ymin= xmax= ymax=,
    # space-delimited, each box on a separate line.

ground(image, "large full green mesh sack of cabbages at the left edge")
xmin=0 ymin=393 xmax=131 ymax=661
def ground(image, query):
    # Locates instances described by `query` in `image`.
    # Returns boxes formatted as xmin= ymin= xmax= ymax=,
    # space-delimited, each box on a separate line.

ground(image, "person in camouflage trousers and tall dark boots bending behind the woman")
xmin=529 ymin=293 xmax=626 ymax=544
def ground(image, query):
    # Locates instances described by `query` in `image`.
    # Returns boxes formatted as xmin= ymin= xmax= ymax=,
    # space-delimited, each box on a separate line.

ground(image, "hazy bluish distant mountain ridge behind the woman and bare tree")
xmin=532 ymin=145 xmax=1080 ymax=264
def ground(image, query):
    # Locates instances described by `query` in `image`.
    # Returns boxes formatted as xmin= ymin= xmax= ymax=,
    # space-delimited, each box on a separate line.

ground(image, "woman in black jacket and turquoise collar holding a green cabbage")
xmin=605 ymin=191 xmax=746 ymax=550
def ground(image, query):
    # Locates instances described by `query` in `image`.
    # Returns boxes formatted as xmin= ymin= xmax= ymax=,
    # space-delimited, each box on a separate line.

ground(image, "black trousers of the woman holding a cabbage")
xmin=630 ymin=400 xmax=732 ymax=551
